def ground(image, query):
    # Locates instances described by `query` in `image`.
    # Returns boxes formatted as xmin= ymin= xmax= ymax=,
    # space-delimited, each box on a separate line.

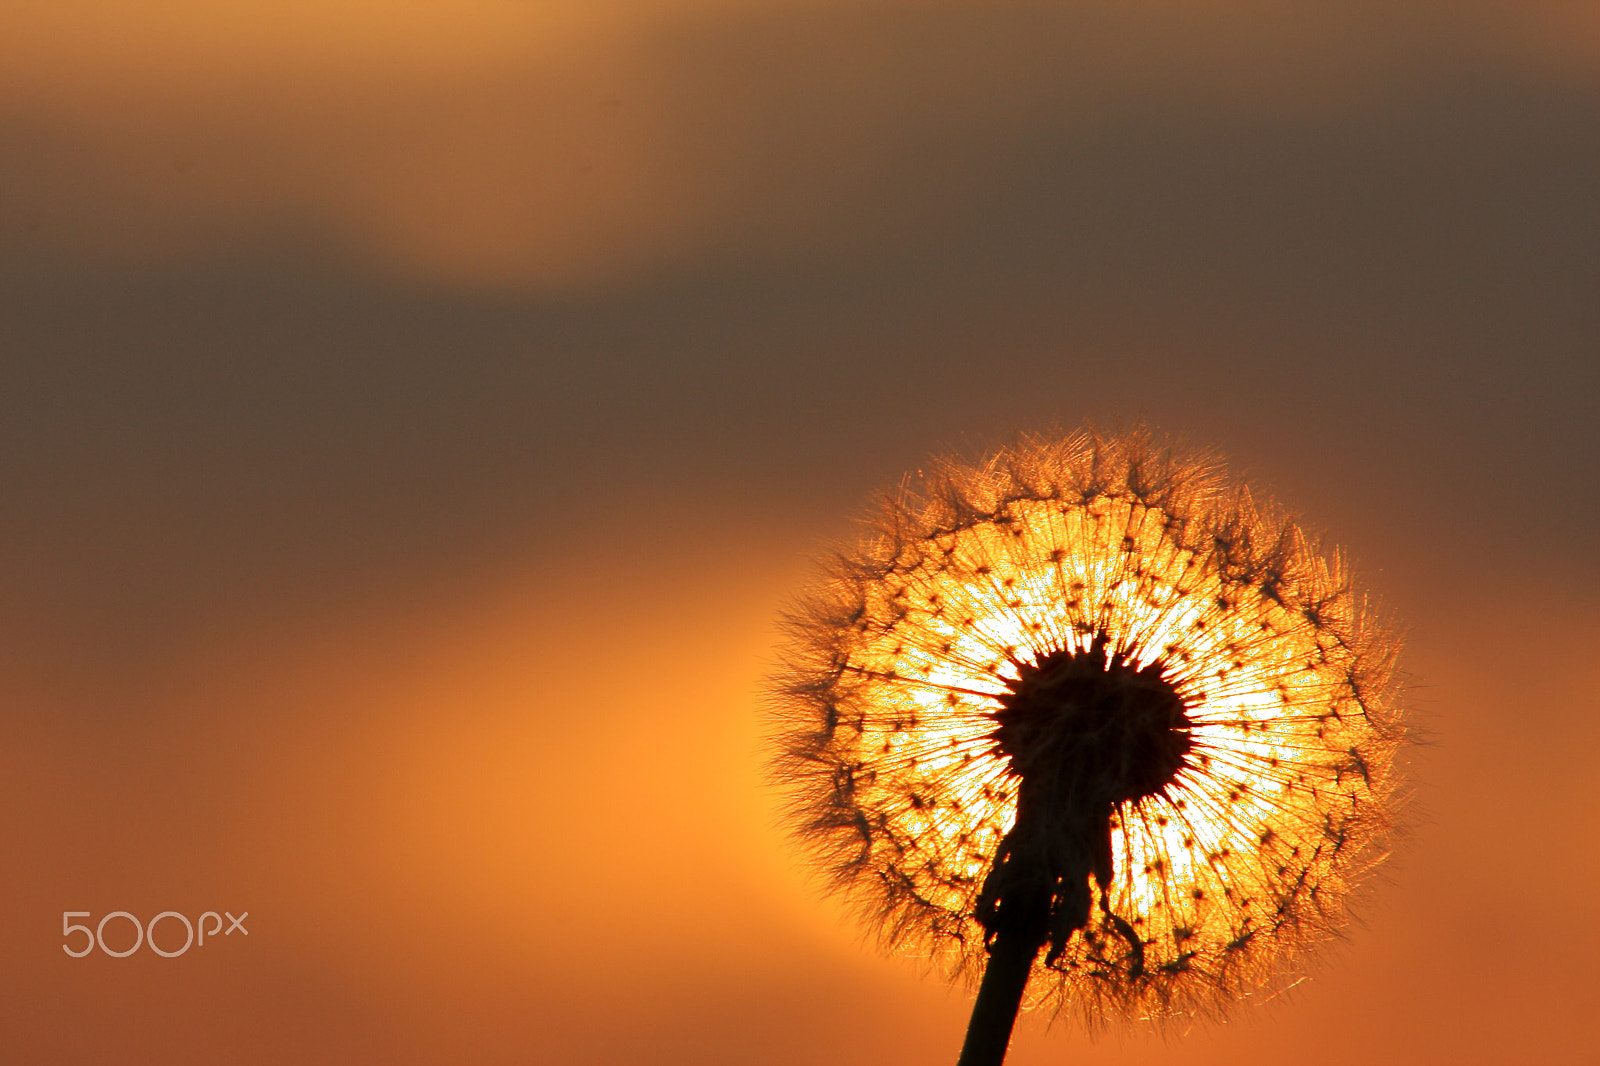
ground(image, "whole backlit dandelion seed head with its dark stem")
xmin=774 ymin=434 xmax=1402 ymax=1066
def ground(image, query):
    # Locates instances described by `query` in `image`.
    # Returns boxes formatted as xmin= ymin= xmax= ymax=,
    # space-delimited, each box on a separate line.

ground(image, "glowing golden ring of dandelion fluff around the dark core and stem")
xmin=779 ymin=439 xmax=1395 ymax=1015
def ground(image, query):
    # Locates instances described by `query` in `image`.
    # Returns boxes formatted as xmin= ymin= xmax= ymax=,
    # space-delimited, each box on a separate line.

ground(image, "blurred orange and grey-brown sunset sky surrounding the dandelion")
xmin=0 ymin=0 xmax=1600 ymax=1066
